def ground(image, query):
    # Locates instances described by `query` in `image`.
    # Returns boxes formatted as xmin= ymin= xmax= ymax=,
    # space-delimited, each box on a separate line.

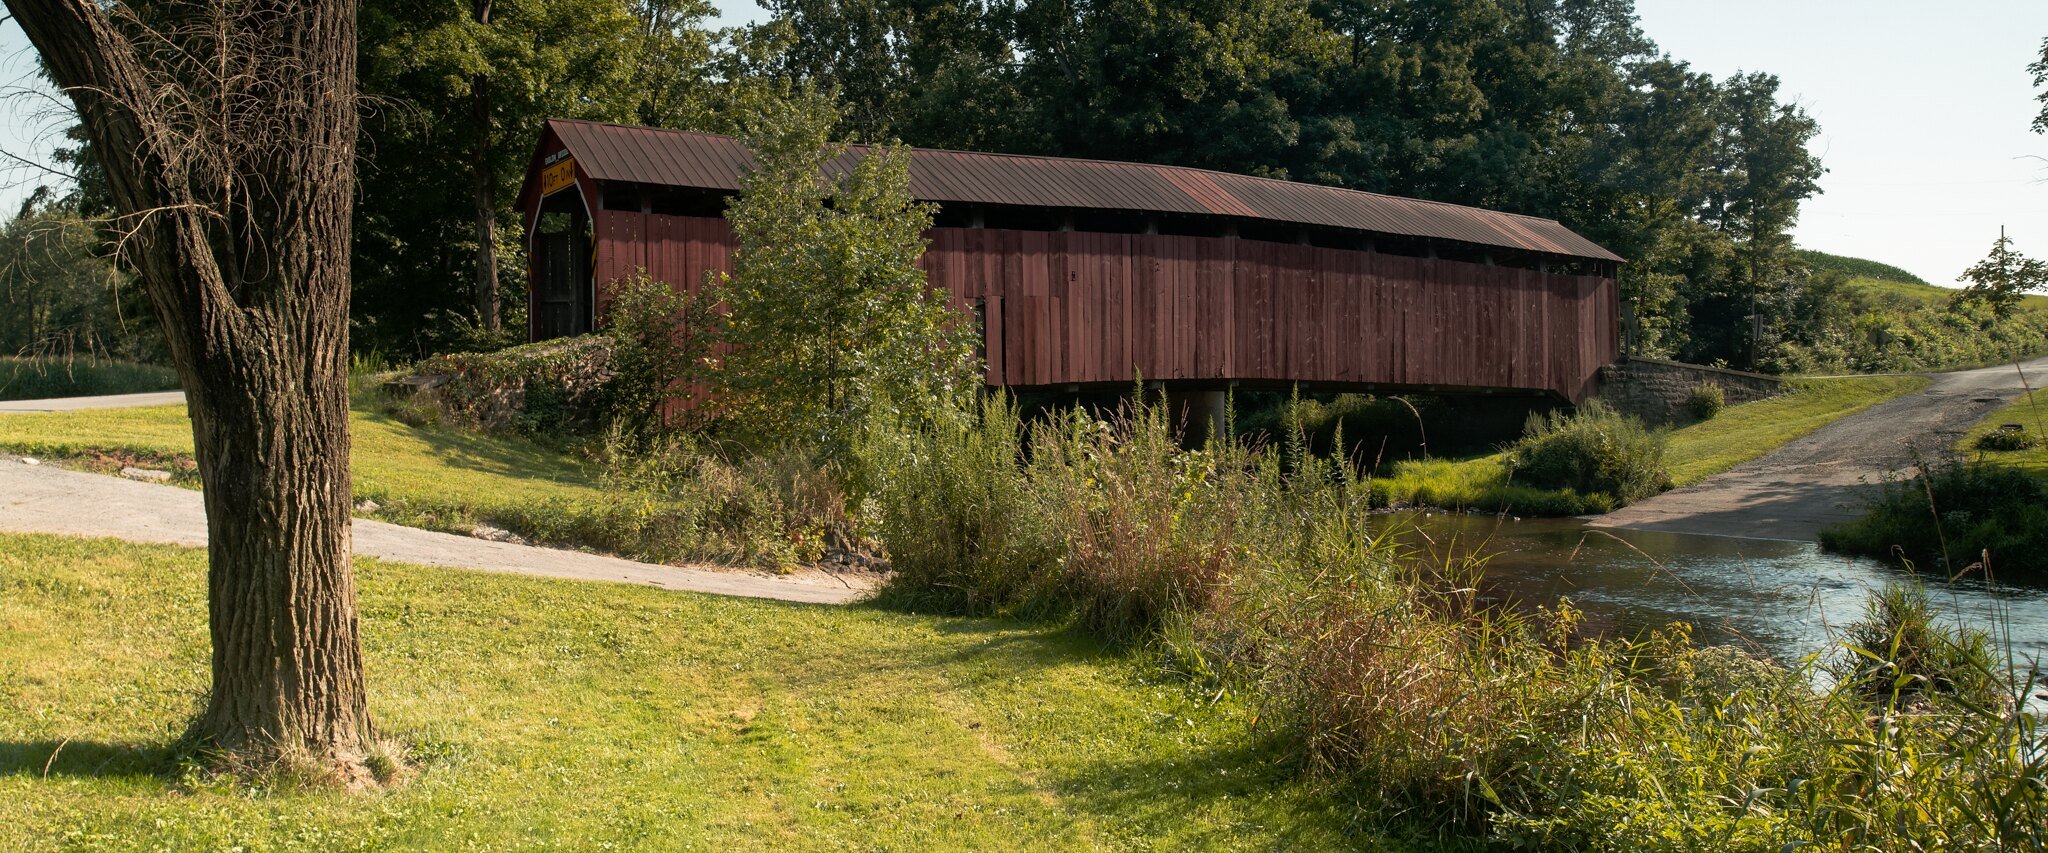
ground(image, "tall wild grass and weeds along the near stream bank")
xmin=870 ymin=390 xmax=2048 ymax=849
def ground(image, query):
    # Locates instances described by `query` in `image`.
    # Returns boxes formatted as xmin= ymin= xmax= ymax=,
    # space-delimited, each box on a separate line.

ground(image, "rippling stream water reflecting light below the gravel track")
xmin=1380 ymin=511 xmax=2048 ymax=667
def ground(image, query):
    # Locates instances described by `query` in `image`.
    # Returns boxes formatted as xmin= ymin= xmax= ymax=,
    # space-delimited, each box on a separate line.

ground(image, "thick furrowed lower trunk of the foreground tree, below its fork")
xmin=186 ymin=249 xmax=373 ymax=773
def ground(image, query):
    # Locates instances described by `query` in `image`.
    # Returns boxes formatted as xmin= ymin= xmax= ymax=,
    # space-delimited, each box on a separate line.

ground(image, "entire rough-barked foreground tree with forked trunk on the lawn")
xmin=6 ymin=0 xmax=375 ymax=783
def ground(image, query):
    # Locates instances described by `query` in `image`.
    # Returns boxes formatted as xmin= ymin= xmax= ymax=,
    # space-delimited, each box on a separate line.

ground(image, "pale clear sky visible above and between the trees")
xmin=0 ymin=0 xmax=2048 ymax=282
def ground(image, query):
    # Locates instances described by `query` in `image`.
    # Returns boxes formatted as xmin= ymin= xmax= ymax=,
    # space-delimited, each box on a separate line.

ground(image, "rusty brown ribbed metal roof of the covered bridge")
xmin=547 ymin=119 xmax=1622 ymax=262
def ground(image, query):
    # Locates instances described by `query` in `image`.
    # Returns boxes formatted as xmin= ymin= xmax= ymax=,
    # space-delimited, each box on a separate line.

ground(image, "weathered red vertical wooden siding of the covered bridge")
xmin=594 ymin=211 xmax=1620 ymax=401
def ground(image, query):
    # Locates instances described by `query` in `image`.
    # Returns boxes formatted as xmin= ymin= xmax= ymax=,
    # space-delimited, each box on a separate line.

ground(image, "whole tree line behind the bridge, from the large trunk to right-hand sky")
xmin=19 ymin=0 xmax=1843 ymax=368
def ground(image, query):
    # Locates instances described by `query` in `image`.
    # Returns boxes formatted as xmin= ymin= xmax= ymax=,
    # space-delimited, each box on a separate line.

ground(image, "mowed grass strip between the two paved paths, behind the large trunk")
xmin=0 ymin=405 xmax=602 ymax=532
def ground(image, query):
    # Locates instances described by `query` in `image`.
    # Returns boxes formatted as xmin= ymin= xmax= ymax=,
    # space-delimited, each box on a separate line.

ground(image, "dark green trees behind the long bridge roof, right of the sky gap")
xmin=770 ymin=0 xmax=1821 ymax=364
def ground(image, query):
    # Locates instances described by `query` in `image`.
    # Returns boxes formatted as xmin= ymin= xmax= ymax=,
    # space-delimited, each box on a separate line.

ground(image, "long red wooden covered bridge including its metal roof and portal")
xmin=520 ymin=121 xmax=1620 ymax=401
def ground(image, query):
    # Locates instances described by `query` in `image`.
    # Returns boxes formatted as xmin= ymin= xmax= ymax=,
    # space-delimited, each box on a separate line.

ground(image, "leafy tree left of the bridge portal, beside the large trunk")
xmin=354 ymin=0 xmax=713 ymax=352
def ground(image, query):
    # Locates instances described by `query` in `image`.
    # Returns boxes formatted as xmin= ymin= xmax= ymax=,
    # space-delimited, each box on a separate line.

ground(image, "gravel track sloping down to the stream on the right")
xmin=1591 ymin=358 xmax=2048 ymax=542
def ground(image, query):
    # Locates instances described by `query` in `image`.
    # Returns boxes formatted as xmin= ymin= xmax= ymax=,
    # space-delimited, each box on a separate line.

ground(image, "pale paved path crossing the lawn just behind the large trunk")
xmin=0 ymin=454 xmax=868 ymax=603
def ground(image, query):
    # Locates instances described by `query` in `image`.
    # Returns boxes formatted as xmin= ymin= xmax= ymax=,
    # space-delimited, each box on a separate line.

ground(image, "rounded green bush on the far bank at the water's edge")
xmin=1505 ymin=399 xmax=1671 ymax=503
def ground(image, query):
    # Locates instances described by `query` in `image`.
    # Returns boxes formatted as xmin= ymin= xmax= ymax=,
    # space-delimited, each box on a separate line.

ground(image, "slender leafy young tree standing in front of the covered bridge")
xmin=705 ymin=96 xmax=975 ymax=452
